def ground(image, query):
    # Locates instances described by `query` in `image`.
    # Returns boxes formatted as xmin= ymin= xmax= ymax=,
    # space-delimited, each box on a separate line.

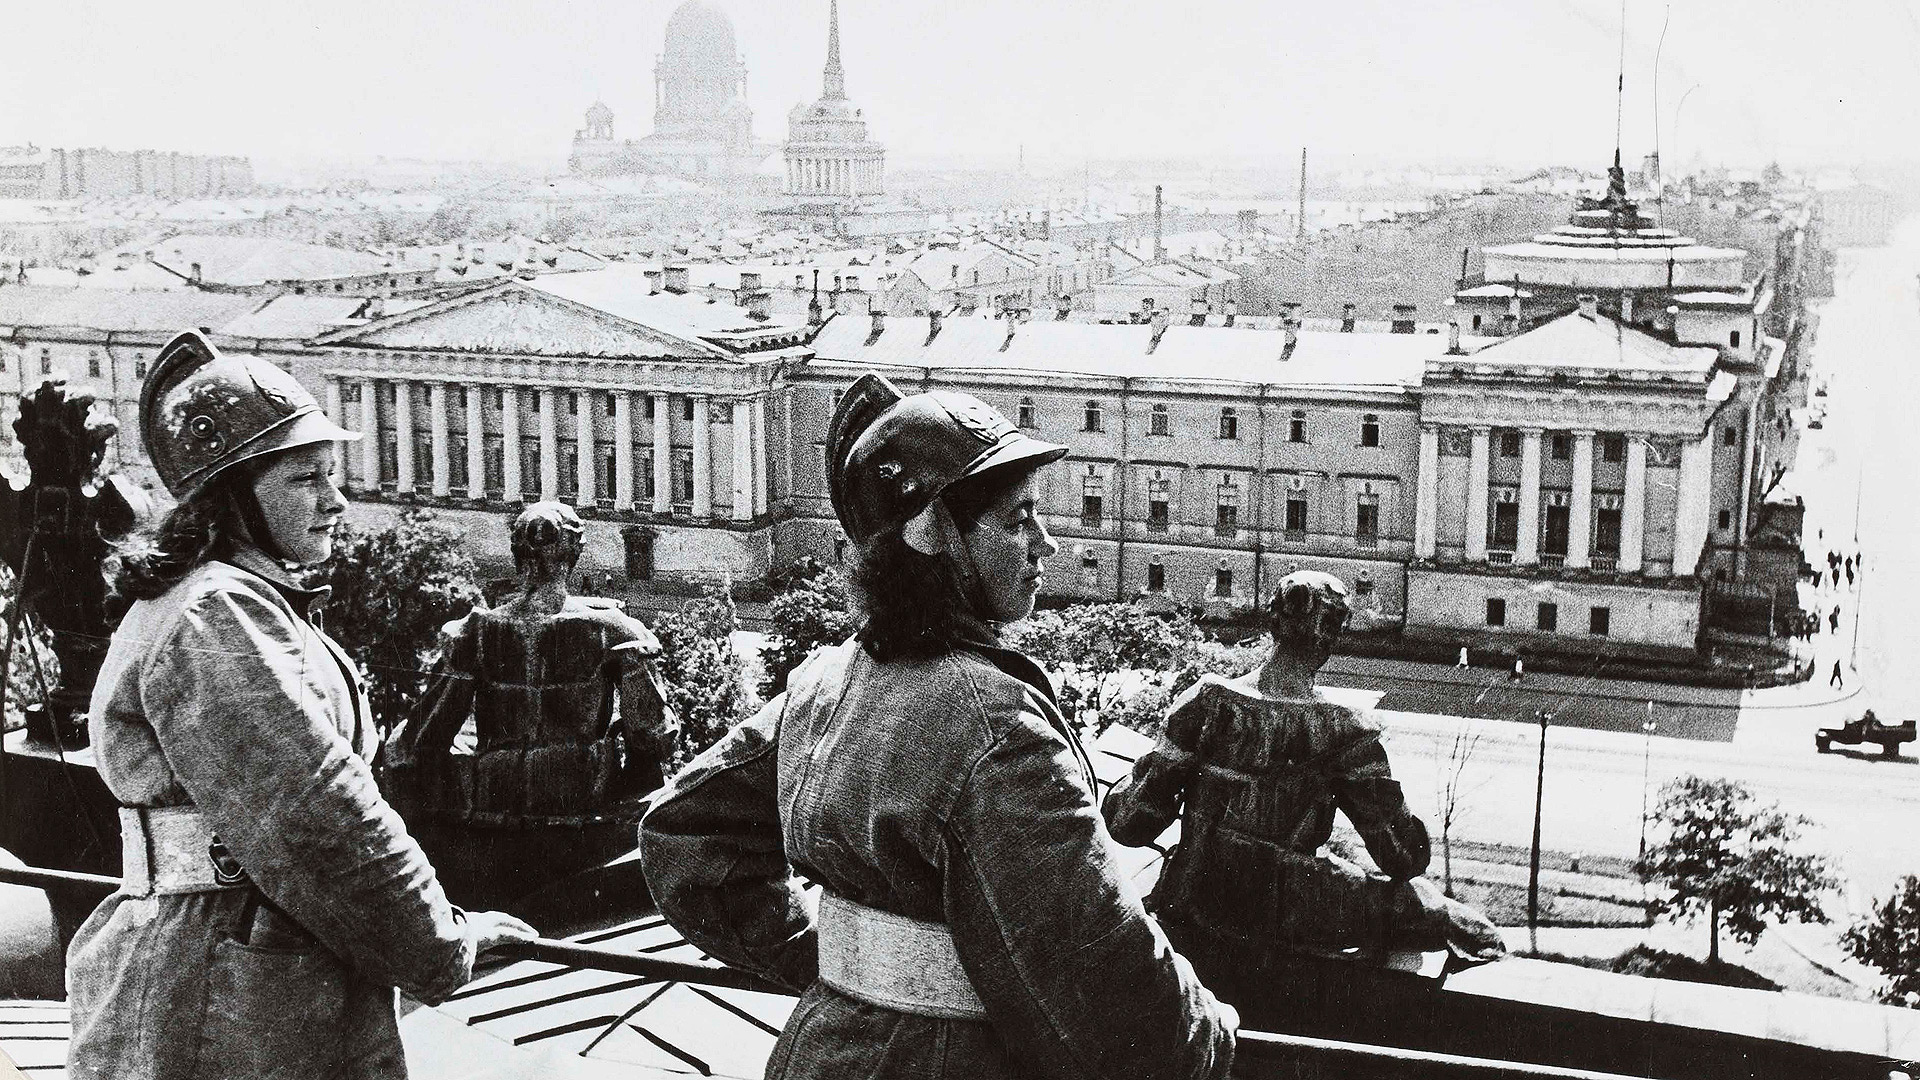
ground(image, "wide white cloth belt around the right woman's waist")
xmin=816 ymin=894 xmax=987 ymax=1020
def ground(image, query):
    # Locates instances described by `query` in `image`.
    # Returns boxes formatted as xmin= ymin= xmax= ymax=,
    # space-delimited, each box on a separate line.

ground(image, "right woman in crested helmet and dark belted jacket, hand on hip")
xmin=641 ymin=375 xmax=1238 ymax=1080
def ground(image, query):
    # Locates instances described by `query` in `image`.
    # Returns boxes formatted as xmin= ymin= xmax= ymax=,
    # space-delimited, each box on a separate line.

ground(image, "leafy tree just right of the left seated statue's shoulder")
xmin=653 ymin=586 xmax=753 ymax=767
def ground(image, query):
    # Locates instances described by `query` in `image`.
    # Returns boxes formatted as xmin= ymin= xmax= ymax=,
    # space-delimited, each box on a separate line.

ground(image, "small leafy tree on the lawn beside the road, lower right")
xmin=1638 ymin=776 xmax=1839 ymax=963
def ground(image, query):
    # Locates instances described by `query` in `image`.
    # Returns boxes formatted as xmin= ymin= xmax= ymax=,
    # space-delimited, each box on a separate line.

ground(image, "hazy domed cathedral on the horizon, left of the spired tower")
xmin=568 ymin=0 xmax=774 ymax=181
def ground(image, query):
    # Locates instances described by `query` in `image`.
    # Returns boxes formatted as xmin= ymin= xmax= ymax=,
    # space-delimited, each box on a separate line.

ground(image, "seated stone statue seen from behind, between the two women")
xmin=382 ymin=502 xmax=680 ymax=903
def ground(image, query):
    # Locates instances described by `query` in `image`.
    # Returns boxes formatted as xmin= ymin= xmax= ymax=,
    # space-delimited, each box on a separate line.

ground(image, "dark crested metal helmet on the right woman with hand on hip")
xmin=828 ymin=375 xmax=1068 ymax=542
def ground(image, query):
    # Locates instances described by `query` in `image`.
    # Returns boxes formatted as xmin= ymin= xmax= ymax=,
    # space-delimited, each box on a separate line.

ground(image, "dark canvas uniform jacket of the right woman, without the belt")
xmin=641 ymin=625 xmax=1235 ymax=1080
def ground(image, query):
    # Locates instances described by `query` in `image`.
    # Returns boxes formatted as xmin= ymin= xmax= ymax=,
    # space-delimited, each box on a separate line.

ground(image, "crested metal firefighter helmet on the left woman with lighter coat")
xmin=140 ymin=331 xmax=359 ymax=500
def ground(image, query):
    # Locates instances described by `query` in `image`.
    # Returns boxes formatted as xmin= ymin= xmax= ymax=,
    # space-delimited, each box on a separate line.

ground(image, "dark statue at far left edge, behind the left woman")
xmin=0 ymin=379 xmax=152 ymax=748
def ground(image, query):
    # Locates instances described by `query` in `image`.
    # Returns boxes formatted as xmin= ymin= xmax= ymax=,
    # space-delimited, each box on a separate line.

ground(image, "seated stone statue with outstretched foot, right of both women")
xmin=1102 ymin=571 xmax=1505 ymax=1005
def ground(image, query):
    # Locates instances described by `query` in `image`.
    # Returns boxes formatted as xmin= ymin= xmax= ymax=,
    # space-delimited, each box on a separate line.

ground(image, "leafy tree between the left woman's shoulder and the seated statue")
xmin=317 ymin=507 xmax=480 ymax=730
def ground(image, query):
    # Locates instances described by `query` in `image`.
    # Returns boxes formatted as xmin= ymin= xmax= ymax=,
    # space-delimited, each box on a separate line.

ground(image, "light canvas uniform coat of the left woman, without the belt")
xmin=67 ymin=552 xmax=474 ymax=1080
